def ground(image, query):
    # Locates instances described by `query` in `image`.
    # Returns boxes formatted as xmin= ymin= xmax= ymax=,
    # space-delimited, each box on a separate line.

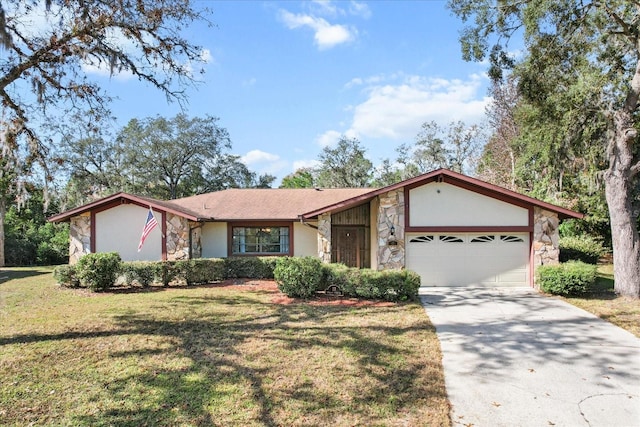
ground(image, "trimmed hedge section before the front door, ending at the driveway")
xmin=274 ymin=257 xmax=420 ymax=301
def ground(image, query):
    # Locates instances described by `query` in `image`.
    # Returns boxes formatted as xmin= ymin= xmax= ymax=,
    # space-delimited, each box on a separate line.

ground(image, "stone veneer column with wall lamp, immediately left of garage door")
xmin=377 ymin=188 xmax=405 ymax=270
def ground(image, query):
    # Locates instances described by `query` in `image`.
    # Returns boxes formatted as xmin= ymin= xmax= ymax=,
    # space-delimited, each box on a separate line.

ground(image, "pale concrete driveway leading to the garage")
xmin=420 ymin=288 xmax=640 ymax=427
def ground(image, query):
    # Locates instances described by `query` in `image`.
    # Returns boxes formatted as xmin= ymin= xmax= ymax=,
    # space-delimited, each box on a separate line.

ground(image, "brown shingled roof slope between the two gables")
xmin=169 ymin=188 xmax=375 ymax=221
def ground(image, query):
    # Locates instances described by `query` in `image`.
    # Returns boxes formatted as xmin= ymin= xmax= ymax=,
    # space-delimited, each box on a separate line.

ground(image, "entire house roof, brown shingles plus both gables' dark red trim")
xmin=49 ymin=169 xmax=584 ymax=226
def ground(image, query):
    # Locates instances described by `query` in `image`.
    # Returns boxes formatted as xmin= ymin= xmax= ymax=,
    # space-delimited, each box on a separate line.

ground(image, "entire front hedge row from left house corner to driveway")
xmin=53 ymin=252 xmax=420 ymax=301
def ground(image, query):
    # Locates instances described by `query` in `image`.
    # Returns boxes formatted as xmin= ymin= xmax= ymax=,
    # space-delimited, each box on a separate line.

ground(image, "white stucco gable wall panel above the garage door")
xmin=409 ymin=182 xmax=529 ymax=226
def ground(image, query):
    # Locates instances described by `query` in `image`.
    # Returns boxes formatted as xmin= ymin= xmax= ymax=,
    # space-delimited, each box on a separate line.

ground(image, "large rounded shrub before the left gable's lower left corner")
xmin=76 ymin=252 xmax=121 ymax=291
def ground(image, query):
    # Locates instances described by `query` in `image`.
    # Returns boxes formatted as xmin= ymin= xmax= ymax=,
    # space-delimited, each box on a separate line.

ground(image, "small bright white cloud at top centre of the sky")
xmin=280 ymin=10 xmax=358 ymax=50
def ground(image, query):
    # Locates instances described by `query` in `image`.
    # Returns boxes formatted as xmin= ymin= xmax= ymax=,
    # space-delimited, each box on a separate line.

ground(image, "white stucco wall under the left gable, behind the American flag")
xmin=95 ymin=204 xmax=162 ymax=261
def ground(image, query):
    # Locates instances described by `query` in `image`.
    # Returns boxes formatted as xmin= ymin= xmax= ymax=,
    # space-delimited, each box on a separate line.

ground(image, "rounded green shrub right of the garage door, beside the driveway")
xmin=538 ymin=261 xmax=597 ymax=296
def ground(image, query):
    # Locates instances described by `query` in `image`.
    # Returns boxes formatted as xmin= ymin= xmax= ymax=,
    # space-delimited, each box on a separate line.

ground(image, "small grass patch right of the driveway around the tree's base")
xmin=565 ymin=264 xmax=640 ymax=338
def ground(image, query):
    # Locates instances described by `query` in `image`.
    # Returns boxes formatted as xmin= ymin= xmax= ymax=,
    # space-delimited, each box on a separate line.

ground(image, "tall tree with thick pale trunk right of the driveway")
xmin=449 ymin=0 xmax=640 ymax=298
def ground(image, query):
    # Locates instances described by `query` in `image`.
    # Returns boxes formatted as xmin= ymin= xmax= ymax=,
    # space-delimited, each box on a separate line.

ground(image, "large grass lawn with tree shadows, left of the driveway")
xmin=0 ymin=268 xmax=450 ymax=426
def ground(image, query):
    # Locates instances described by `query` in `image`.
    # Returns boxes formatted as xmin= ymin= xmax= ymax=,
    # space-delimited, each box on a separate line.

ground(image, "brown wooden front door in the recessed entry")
xmin=331 ymin=226 xmax=370 ymax=268
